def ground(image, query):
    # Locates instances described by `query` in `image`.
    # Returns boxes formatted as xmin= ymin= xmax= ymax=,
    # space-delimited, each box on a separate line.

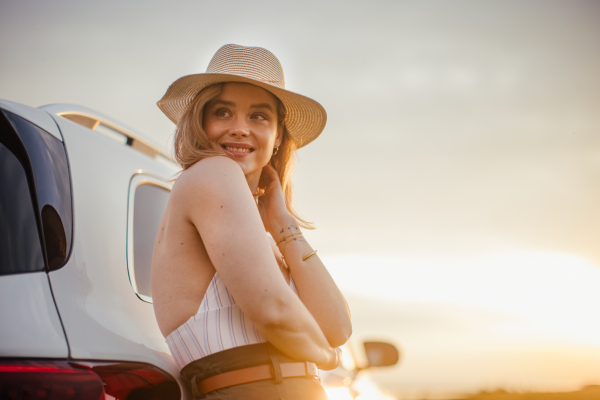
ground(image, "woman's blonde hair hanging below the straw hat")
xmin=173 ymin=82 xmax=314 ymax=229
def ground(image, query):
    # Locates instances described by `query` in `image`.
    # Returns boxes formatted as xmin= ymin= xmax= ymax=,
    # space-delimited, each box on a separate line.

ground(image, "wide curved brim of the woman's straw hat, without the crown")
xmin=156 ymin=73 xmax=327 ymax=148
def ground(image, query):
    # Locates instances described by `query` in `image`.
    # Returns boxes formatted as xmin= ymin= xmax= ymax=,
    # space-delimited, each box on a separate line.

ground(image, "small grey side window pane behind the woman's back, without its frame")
xmin=133 ymin=184 xmax=171 ymax=297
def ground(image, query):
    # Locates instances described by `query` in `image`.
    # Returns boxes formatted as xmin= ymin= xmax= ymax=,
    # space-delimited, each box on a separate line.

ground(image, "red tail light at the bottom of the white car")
xmin=0 ymin=360 xmax=181 ymax=400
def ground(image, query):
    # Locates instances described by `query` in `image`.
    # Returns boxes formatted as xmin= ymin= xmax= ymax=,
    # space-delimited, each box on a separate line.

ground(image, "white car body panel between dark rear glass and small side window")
xmin=49 ymin=116 xmax=177 ymax=362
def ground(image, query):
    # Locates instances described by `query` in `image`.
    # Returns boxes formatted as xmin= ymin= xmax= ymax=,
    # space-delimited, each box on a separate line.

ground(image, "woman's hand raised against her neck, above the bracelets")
xmin=258 ymin=164 xmax=292 ymax=238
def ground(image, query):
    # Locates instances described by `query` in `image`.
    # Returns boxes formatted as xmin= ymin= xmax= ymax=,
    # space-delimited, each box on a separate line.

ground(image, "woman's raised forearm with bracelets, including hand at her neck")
xmin=259 ymin=165 xmax=352 ymax=347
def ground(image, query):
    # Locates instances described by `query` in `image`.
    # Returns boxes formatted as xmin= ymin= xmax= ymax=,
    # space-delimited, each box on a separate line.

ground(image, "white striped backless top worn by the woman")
xmin=165 ymin=272 xmax=298 ymax=370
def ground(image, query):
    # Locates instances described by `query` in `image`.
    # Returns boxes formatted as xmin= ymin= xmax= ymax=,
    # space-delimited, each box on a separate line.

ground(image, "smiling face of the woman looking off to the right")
xmin=202 ymin=82 xmax=281 ymax=179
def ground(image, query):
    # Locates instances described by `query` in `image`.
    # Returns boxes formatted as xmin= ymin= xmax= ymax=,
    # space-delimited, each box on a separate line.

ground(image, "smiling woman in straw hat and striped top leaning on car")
xmin=152 ymin=45 xmax=351 ymax=399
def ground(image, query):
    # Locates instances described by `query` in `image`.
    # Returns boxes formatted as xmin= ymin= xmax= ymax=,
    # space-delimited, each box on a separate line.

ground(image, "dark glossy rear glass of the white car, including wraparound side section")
xmin=0 ymin=110 xmax=73 ymax=274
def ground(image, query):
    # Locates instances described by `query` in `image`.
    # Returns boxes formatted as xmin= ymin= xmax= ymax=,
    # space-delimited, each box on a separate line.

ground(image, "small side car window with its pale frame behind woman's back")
xmin=128 ymin=175 xmax=171 ymax=302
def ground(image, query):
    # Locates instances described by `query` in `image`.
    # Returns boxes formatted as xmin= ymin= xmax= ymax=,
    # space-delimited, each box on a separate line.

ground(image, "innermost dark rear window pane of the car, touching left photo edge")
xmin=0 ymin=143 xmax=44 ymax=275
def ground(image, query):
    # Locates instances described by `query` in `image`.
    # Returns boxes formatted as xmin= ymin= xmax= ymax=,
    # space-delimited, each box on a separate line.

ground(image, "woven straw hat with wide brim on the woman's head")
xmin=156 ymin=44 xmax=327 ymax=148
